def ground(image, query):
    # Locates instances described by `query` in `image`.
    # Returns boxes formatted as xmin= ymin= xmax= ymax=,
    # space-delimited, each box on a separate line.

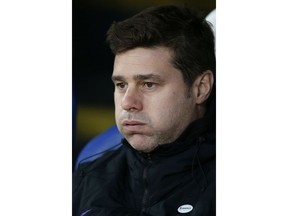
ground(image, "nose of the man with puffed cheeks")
xmin=121 ymin=87 xmax=143 ymax=112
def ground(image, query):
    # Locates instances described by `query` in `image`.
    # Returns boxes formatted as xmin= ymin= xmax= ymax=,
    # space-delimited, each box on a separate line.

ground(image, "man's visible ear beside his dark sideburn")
xmin=193 ymin=70 xmax=214 ymax=104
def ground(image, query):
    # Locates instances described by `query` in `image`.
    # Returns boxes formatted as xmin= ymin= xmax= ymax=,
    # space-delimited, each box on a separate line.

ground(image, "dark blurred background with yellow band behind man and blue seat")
xmin=72 ymin=0 xmax=216 ymax=167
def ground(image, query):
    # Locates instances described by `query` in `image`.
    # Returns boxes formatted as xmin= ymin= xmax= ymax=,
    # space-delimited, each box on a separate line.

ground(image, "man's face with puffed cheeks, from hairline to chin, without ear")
xmin=112 ymin=47 xmax=196 ymax=152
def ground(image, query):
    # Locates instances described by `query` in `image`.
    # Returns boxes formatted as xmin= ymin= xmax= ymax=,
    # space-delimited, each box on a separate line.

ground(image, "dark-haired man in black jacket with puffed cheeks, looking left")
xmin=73 ymin=6 xmax=215 ymax=216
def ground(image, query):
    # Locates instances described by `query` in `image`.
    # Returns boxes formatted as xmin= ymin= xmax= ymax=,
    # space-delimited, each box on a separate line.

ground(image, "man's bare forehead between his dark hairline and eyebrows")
xmin=113 ymin=47 xmax=177 ymax=76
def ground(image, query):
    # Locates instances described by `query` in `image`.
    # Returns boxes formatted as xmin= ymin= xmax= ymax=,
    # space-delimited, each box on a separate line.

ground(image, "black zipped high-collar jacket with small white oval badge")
xmin=73 ymin=116 xmax=216 ymax=216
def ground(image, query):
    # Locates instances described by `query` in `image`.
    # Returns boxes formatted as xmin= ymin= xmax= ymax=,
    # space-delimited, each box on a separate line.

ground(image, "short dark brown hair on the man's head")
xmin=107 ymin=5 xmax=216 ymax=89
